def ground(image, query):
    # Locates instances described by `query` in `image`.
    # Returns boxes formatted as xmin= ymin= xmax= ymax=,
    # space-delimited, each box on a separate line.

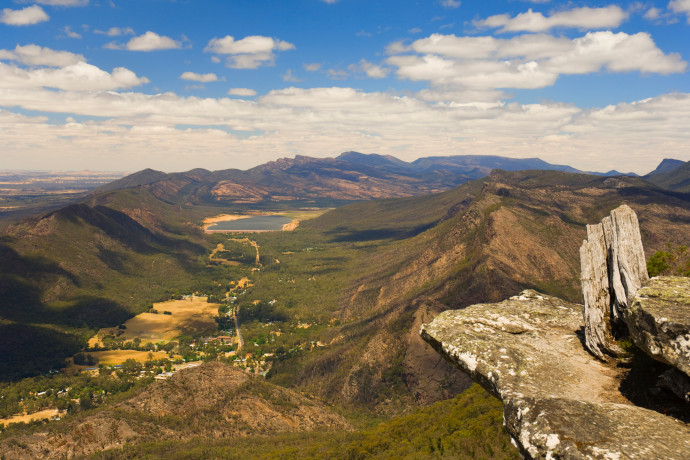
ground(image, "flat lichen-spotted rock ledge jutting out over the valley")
xmin=421 ymin=290 xmax=690 ymax=460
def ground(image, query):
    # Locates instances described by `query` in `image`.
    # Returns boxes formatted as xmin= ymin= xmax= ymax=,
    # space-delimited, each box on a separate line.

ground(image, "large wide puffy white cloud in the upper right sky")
xmin=385 ymin=31 xmax=687 ymax=91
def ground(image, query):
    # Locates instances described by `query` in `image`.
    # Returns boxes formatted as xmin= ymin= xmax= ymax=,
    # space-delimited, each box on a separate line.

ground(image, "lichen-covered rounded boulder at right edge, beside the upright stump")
xmin=626 ymin=276 xmax=690 ymax=376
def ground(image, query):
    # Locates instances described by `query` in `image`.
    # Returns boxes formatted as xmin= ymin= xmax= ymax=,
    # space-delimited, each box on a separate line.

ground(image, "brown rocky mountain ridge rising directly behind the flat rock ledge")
xmin=286 ymin=171 xmax=690 ymax=408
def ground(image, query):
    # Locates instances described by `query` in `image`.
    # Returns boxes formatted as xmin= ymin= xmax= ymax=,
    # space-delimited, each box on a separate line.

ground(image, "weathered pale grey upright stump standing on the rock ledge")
xmin=580 ymin=205 xmax=649 ymax=360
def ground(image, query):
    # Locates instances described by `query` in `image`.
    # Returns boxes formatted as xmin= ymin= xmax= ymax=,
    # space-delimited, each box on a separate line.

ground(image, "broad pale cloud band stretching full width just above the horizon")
xmin=0 ymin=85 xmax=690 ymax=173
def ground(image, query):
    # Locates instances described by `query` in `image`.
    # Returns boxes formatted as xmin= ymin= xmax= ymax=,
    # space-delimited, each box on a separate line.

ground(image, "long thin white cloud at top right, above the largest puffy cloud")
xmin=474 ymin=5 xmax=628 ymax=32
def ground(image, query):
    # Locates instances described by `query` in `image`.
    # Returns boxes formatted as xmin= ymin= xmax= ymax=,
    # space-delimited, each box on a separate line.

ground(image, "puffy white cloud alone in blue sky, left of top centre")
xmin=204 ymin=35 xmax=295 ymax=69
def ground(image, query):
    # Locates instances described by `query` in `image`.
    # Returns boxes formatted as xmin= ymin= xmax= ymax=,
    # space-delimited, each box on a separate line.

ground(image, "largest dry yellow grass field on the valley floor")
xmin=89 ymin=297 xmax=219 ymax=346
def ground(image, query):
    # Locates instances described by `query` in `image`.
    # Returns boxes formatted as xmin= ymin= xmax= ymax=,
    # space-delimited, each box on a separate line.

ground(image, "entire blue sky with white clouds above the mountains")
xmin=0 ymin=0 xmax=690 ymax=174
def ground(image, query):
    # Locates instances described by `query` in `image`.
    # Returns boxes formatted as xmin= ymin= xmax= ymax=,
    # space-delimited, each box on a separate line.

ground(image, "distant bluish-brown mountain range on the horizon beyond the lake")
xmin=94 ymin=152 xmax=640 ymax=207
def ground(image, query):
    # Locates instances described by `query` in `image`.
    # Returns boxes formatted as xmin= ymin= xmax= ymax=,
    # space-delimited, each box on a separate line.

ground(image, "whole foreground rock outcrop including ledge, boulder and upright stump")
xmin=421 ymin=207 xmax=690 ymax=459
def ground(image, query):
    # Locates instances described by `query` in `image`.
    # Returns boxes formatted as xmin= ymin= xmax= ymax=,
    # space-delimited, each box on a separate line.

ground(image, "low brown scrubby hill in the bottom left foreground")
xmin=0 ymin=363 xmax=350 ymax=460
